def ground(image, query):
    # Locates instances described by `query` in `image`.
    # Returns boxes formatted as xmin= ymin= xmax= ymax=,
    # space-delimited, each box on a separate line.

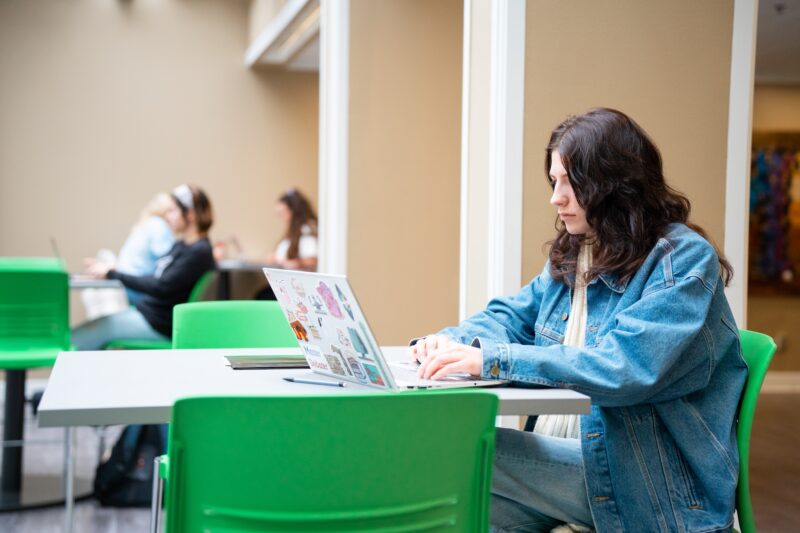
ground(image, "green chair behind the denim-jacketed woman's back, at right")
xmin=736 ymin=329 xmax=777 ymax=533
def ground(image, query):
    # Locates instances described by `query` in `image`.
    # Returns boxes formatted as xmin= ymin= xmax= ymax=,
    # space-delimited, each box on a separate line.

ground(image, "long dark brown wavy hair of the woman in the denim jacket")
xmin=545 ymin=108 xmax=733 ymax=285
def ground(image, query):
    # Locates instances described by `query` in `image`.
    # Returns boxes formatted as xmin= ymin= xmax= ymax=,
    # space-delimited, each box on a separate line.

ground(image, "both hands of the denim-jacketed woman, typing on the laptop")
xmin=409 ymin=335 xmax=483 ymax=379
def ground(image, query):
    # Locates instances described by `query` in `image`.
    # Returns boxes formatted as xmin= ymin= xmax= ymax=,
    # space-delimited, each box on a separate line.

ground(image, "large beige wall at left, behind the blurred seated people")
xmin=0 ymin=0 xmax=318 ymax=278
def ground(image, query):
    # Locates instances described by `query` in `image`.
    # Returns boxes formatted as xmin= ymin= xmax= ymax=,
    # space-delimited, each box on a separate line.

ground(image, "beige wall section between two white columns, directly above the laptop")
xmin=347 ymin=0 xmax=463 ymax=344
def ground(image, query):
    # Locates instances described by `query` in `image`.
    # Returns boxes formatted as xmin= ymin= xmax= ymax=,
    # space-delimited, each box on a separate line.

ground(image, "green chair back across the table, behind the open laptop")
xmin=172 ymin=300 xmax=298 ymax=348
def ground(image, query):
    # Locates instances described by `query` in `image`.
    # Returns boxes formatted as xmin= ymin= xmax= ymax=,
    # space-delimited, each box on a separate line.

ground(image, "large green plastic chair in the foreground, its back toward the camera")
xmin=151 ymin=391 xmax=497 ymax=533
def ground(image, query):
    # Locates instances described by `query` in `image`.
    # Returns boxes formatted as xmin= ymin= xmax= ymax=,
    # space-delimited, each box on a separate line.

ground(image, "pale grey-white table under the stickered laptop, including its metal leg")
xmin=39 ymin=346 xmax=590 ymax=531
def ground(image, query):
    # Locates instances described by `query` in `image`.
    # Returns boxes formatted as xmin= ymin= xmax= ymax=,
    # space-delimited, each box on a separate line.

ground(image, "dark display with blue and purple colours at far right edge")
xmin=750 ymin=147 xmax=800 ymax=283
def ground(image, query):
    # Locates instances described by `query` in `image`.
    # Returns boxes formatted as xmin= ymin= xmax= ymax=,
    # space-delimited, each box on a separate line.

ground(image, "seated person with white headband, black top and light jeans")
xmin=72 ymin=185 xmax=215 ymax=350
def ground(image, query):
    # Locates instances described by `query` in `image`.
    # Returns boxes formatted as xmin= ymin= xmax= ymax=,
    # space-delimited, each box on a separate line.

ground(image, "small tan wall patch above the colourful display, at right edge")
xmin=753 ymin=85 xmax=800 ymax=132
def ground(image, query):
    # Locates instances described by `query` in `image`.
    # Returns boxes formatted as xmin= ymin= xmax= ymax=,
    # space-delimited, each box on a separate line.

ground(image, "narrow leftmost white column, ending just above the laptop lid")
xmin=318 ymin=0 xmax=350 ymax=274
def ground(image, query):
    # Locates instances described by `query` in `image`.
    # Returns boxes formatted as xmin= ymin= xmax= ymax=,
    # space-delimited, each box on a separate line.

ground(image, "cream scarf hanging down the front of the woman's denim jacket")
xmin=533 ymin=244 xmax=592 ymax=439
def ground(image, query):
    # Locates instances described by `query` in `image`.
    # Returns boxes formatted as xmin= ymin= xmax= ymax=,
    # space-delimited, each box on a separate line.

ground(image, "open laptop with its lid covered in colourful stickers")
xmin=263 ymin=268 xmax=505 ymax=390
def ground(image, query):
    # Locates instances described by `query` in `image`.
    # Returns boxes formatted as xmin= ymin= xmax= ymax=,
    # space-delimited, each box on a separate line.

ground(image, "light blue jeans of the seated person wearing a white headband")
xmin=72 ymin=308 xmax=169 ymax=350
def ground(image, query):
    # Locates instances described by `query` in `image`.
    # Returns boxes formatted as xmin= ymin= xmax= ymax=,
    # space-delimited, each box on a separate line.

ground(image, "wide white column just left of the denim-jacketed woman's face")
xmin=459 ymin=0 xmax=525 ymax=428
